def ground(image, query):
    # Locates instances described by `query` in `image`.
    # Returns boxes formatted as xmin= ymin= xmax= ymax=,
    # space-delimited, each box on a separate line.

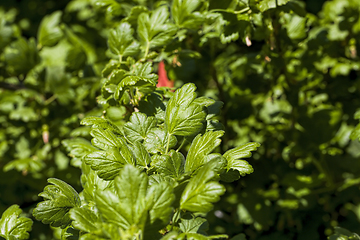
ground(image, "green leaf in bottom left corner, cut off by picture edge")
xmin=0 ymin=205 xmax=33 ymax=240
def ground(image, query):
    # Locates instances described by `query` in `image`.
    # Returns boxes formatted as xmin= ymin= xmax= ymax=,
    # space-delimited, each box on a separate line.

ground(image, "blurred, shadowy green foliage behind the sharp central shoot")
xmin=0 ymin=0 xmax=360 ymax=240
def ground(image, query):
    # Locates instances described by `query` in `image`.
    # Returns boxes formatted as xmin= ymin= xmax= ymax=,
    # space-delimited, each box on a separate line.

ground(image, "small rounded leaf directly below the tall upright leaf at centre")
xmin=144 ymin=128 xmax=177 ymax=154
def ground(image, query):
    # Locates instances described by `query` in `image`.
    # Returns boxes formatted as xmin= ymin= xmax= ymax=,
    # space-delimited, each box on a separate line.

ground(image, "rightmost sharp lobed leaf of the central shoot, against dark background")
xmin=224 ymin=142 xmax=260 ymax=176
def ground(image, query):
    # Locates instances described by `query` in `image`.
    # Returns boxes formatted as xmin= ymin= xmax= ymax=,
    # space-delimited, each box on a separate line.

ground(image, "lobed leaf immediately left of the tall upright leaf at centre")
xmin=123 ymin=112 xmax=156 ymax=143
